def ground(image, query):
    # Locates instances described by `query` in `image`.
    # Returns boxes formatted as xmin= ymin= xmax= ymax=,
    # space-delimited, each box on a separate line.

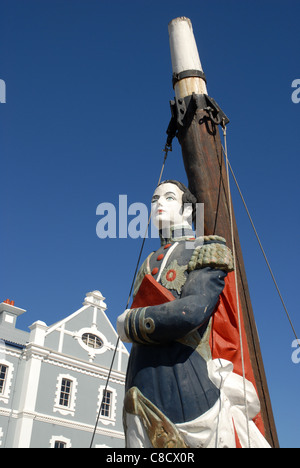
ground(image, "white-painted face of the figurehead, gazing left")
xmin=151 ymin=183 xmax=191 ymax=229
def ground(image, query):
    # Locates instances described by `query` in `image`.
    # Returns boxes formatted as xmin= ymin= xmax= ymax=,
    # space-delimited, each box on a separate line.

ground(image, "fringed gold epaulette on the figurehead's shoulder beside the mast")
xmin=188 ymin=236 xmax=234 ymax=272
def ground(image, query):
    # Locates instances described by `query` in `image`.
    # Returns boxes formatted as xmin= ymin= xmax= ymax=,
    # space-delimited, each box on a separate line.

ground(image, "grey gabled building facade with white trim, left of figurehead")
xmin=0 ymin=291 xmax=129 ymax=448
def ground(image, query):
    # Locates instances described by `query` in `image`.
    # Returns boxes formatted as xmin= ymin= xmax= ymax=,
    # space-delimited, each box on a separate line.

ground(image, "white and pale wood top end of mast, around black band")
xmin=168 ymin=17 xmax=207 ymax=99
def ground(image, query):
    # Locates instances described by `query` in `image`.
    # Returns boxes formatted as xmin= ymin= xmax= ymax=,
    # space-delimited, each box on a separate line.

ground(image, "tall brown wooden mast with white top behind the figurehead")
xmin=168 ymin=17 xmax=279 ymax=447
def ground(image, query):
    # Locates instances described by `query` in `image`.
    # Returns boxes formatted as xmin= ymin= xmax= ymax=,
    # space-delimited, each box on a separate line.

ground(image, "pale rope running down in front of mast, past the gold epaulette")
xmin=222 ymin=124 xmax=251 ymax=448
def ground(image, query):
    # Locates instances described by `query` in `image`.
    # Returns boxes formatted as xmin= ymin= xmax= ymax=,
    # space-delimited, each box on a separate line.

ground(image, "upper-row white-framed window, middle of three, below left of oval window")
xmin=53 ymin=374 xmax=77 ymax=416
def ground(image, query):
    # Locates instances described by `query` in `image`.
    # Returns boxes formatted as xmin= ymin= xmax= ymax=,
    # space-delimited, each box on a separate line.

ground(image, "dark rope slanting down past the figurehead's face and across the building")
xmin=89 ymin=143 xmax=172 ymax=448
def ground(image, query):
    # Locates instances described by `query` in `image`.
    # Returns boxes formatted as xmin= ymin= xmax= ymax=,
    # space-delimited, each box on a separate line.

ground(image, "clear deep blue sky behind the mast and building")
xmin=0 ymin=0 xmax=300 ymax=447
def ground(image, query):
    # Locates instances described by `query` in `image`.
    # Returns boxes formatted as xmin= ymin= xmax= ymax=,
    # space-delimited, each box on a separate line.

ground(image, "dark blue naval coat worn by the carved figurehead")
xmin=125 ymin=232 xmax=229 ymax=424
